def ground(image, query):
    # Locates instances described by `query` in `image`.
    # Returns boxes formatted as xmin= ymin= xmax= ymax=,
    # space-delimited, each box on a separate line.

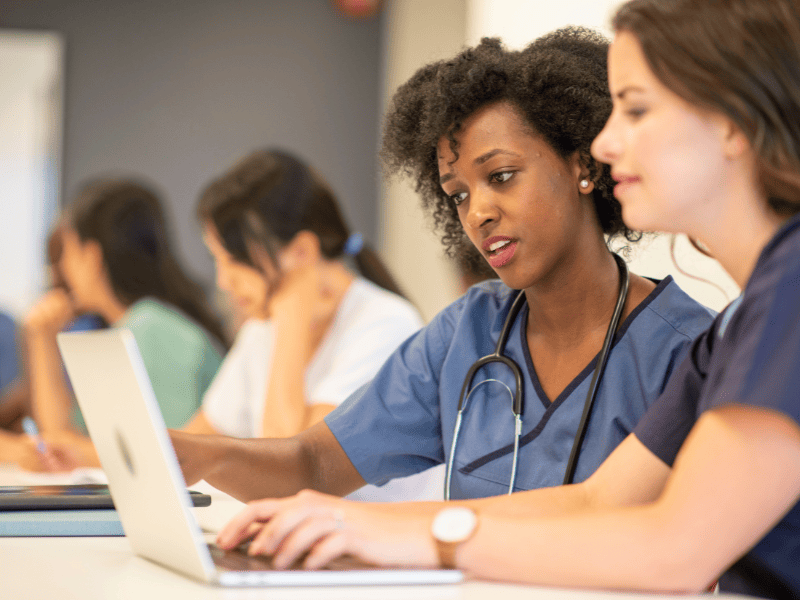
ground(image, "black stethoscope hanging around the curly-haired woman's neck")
xmin=444 ymin=254 xmax=630 ymax=500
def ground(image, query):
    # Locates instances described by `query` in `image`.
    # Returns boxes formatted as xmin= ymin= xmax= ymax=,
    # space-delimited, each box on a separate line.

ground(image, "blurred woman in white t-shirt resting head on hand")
xmin=185 ymin=150 xmax=441 ymax=500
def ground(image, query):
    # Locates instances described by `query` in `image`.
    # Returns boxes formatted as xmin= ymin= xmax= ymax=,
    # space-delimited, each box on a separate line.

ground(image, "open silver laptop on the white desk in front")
xmin=58 ymin=329 xmax=463 ymax=586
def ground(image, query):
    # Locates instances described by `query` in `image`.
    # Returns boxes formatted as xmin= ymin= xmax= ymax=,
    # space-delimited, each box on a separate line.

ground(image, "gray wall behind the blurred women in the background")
xmin=0 ymin=0 xmax=381 ymax=282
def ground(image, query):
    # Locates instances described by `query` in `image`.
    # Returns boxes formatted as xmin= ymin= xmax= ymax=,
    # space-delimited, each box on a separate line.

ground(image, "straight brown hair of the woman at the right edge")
xmin=613 ymin=0 xmax=800 ymax=215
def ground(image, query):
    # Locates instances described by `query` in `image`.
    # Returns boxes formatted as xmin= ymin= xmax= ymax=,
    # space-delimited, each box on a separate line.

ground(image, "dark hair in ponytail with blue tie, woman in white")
xmin=197 ymin=150 xmax=403 ymax=296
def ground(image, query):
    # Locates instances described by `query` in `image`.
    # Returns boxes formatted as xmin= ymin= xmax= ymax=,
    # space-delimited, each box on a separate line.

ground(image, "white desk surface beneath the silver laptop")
xmin=0 ymin=468 xmax=764 ymax=600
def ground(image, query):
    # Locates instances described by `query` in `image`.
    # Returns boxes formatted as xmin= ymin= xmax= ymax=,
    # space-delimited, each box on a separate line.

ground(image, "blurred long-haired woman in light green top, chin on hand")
xmin=18 ymin=179 xmax=225 ymax=466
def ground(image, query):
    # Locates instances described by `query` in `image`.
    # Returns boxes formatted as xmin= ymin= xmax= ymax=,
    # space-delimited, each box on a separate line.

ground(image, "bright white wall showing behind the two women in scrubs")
xmin=467 ymin=0 xmax=739 ymax=310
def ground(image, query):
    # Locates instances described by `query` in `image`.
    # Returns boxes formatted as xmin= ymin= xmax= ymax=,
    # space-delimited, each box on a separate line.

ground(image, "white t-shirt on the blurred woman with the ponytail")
xmin=203 ymin=278 xmax=444 ymax=502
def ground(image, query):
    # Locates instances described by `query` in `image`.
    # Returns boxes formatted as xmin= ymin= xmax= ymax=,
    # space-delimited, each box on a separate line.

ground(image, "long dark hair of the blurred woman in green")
xmin=69 ymin=180 xmax=227 ymax=348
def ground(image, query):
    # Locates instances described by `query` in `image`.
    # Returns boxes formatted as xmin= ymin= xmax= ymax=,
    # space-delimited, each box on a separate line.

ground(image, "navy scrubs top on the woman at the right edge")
xmin=634 ymin=215 xmax=800 ymax=598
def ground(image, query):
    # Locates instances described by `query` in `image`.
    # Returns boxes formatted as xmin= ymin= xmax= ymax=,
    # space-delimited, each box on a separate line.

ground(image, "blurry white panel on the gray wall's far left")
xmin=0 ymin=30 xmax=64 ymax=318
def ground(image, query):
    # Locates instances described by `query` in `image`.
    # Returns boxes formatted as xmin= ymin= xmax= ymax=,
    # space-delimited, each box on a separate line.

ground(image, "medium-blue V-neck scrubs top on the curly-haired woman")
xmin=325 ymin=277 xmax=712 ymax=499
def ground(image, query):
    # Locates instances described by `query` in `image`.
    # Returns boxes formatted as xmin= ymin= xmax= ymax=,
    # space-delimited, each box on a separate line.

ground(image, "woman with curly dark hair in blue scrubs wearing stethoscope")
xmin=169 ymin=29 xmax=711 ymax=528
